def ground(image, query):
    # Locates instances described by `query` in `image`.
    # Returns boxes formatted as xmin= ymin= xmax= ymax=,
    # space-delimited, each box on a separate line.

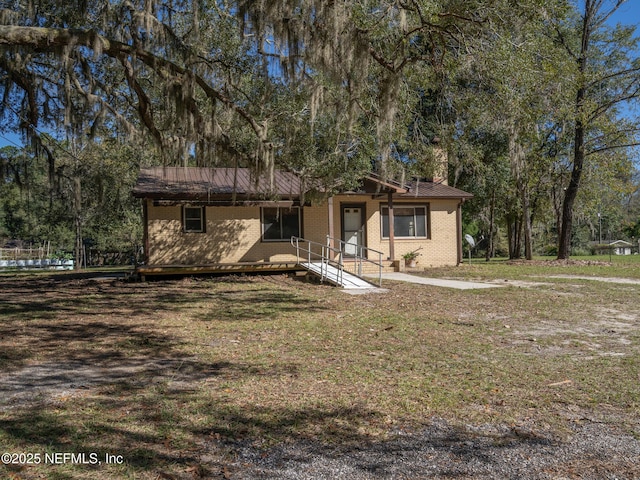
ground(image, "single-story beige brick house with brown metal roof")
xmin=133 ymin=167 xmax=472 ymax=276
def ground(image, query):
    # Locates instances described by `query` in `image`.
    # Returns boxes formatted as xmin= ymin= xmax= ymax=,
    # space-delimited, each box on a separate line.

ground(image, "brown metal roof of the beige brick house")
xmin=133 ymin=167 xmax=473 ymax=204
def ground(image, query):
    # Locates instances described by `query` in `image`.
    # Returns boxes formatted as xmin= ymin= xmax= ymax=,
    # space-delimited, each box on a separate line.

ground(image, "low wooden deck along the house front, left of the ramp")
xmin=135 ymin=261 xmax=304 ymax=282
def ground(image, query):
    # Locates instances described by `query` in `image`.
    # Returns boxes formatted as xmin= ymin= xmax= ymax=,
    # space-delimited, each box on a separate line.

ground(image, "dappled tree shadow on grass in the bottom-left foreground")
xmin=0 ymin=361 xmax=378 ymax=478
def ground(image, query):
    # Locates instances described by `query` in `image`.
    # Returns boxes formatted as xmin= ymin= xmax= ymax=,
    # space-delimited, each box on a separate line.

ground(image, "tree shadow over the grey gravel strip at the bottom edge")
xmin=214 ymin=414 xmax=557 ymax=479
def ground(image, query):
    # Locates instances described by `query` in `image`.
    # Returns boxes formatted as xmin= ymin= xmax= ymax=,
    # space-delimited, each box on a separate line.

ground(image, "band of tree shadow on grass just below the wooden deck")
xmin=0 ymin=270 xmax=330 ymax=326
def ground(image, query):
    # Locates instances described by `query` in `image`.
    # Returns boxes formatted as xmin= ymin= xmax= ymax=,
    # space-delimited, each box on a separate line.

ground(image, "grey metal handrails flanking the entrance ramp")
xmin=291 ymin=235 xmax=383 ymax=285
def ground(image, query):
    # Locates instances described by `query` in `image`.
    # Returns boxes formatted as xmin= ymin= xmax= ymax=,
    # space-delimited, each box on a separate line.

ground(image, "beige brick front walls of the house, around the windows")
xmin=148 ymin=195 xmax=458 ymax=267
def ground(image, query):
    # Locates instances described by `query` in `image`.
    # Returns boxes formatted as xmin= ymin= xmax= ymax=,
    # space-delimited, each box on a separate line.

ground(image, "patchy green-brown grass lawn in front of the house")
xmin=0 ymin=256 xmax=640 ymax=480
